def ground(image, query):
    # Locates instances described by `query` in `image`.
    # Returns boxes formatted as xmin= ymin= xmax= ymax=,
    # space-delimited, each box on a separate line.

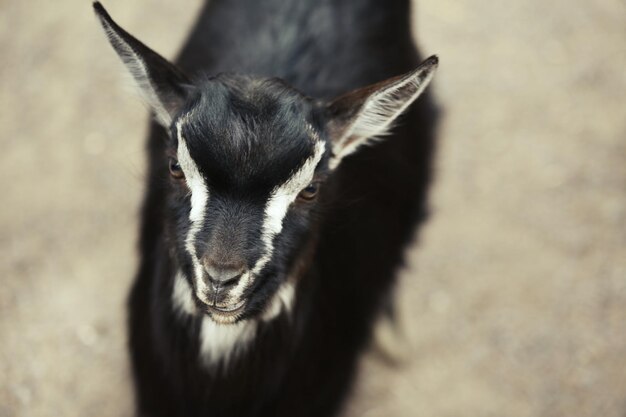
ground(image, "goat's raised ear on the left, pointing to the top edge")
xmin=93 ymin=1 xmax=191 ymax=127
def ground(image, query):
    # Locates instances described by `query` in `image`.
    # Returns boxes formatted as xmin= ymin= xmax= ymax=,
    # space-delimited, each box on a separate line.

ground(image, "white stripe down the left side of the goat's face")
xmin=176 ymin=116 xmax=209 ymax=302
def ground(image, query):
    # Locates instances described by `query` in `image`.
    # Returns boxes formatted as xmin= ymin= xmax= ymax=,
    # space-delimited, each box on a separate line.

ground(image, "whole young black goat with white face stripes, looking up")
xmin=94 ymin=0 xmax=438 ymax=417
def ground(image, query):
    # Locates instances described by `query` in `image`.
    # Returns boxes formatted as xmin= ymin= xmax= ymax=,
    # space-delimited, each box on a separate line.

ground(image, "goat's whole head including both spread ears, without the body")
xmin=94 ymin=3 xmax=438 ymax=323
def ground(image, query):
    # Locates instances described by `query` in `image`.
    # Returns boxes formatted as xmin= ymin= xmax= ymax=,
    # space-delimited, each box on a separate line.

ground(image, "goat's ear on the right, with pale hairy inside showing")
xmin=327 ymin=56 xmax=439 ymax=168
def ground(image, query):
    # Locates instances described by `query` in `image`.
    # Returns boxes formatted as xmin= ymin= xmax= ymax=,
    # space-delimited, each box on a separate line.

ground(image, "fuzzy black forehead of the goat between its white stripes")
xmin=182 ymin=90 xmax=317 ymax=192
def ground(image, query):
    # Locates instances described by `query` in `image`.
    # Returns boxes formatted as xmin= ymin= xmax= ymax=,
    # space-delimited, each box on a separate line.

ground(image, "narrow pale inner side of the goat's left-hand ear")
xmin=100 ymin=18 xmax=172 ymax=127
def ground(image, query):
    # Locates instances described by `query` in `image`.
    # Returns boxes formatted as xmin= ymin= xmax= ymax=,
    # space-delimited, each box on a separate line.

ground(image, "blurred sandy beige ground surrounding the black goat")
xmin=0 ymin=0 xmax=626 ymax=417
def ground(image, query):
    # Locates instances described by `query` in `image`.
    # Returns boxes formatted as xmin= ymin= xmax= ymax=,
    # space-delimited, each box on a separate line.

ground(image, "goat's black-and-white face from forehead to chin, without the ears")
xmin=169 ymin=74 xmax=330 ymax=323
